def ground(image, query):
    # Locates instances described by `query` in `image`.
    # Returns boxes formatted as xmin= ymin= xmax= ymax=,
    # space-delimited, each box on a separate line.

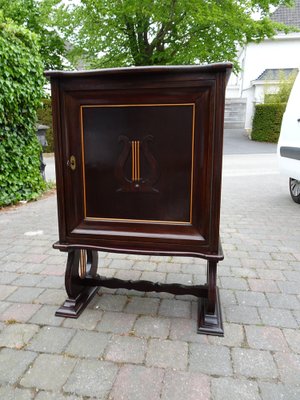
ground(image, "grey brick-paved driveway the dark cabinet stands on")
xmin=0 ymin=152 xmax=300 ymax=400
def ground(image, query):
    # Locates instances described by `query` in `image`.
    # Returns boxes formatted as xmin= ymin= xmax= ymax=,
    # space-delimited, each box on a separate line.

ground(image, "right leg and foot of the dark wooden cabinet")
xmin=198 ymin=260 xmax=224 ymax=336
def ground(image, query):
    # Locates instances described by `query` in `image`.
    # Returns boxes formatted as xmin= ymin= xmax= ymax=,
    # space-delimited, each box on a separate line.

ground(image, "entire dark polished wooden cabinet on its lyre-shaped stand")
xmin=46 ymin=63 xmax=232 ymax=335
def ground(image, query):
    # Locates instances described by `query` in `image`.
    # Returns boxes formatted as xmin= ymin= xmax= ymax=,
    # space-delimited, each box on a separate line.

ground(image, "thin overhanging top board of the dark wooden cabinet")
xmin=45 ymin=63 xmax=232 ymax=78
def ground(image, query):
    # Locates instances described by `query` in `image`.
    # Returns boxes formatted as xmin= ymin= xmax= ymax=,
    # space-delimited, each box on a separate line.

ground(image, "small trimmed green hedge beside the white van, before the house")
xmin=251 ymin=103 xmax=286 ymax=143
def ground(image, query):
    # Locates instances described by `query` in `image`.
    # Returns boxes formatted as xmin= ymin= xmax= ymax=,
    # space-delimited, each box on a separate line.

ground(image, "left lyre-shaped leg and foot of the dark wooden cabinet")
xmin=55 ymin=250 xmax=98 ymax=318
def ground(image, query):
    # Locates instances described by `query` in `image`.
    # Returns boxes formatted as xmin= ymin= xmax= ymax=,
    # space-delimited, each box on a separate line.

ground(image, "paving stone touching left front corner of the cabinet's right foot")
xmin=170 ymin=318 xmax=208 ymax=343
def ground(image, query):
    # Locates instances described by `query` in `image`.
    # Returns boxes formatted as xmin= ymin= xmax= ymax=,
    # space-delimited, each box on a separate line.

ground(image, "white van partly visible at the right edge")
xmin=277 ymin=68 xmax=300 ymax=204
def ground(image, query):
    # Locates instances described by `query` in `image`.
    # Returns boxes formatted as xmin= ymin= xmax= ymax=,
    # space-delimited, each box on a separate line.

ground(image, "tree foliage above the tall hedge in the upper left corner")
xmin=0 ymin=0 xmax=66 ymax=69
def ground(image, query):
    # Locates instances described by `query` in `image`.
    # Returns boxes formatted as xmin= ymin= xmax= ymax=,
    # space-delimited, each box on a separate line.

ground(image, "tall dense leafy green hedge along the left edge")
xmin=0 ymin=21 xmax=45 ymax=206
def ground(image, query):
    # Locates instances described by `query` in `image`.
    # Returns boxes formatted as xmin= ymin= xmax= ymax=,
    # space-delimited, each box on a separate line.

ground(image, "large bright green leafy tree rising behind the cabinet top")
xmin=57 ymin=0 xmax=293 ymax=67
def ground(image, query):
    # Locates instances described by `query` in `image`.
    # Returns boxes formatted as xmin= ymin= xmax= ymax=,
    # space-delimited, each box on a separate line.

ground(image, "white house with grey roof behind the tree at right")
xmin=226 ymin=0 xmax=300 ymax=134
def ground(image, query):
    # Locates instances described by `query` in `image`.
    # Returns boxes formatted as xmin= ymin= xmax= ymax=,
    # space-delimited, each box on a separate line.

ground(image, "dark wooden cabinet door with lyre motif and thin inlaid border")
xmin=56 ymin=82 xmax=219 ymax=253
